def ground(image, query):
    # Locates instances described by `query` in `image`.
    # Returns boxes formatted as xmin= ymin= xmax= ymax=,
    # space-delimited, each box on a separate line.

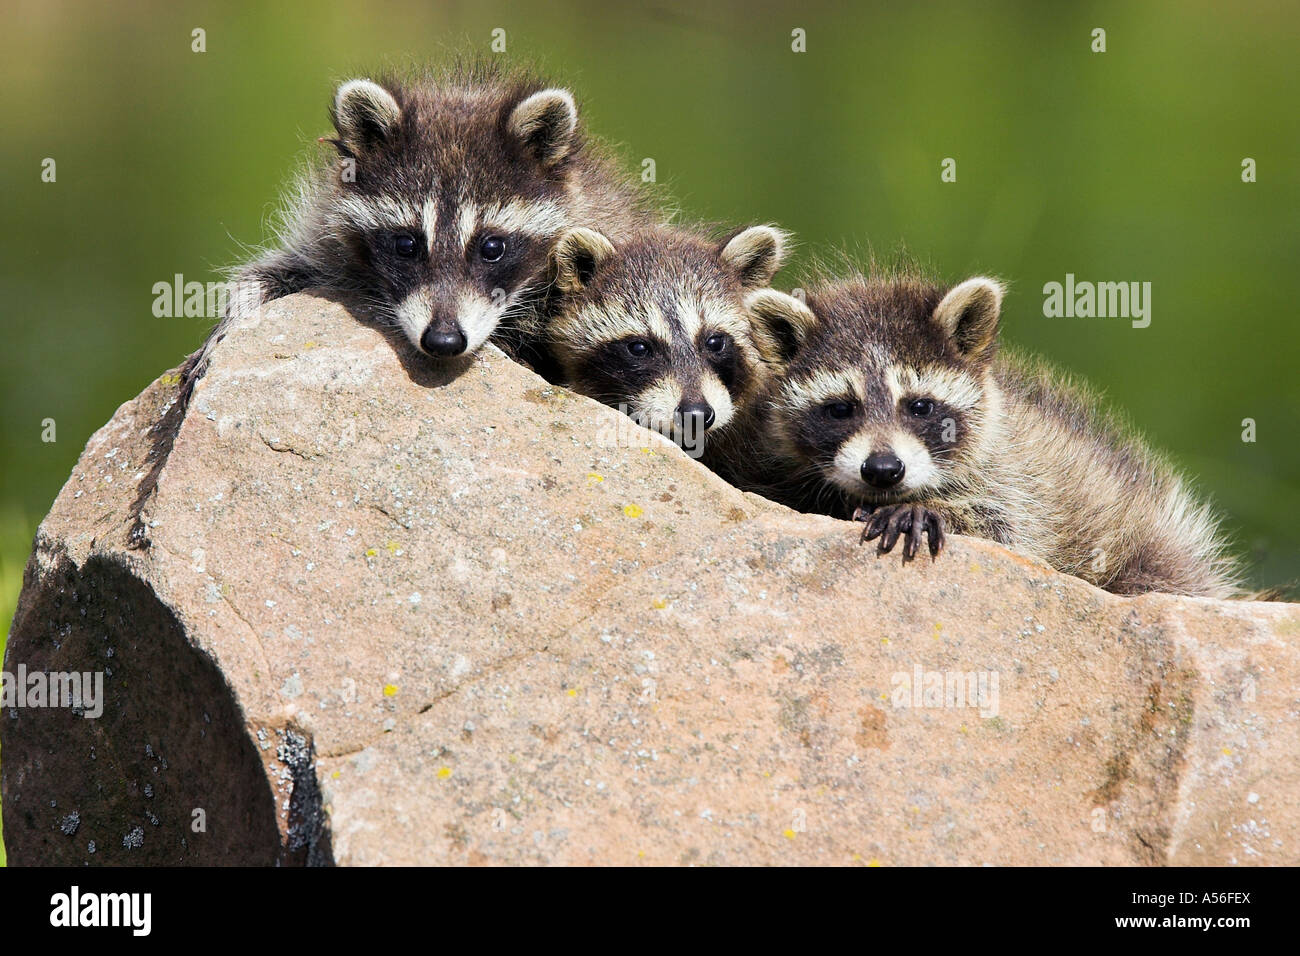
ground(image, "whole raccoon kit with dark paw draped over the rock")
xmin=719 ymin=274 xmax=1240 ymax=597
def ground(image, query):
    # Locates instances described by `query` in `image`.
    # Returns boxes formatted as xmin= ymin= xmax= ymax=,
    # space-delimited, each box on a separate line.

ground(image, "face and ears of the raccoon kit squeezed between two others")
xmin=546 ymin=226 xmax=785 ymax=451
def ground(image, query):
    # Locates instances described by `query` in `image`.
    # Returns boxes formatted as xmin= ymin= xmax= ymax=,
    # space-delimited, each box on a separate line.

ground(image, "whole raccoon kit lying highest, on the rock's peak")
xmin=186 ymin=66 xmax=654 ymax=400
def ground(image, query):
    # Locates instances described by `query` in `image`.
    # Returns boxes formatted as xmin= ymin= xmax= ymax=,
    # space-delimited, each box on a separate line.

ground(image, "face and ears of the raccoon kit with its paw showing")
xmin=774 ymin=278 xmax=1004 ymax=505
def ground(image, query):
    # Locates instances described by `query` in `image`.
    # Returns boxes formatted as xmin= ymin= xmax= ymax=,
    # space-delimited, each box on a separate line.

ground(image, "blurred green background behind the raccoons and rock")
xmin=0 ymin=0 xmax=1300 ymax=858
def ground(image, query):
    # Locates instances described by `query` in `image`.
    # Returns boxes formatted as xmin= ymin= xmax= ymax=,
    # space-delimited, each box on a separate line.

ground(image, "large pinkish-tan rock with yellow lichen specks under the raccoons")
xmin=0 ymin=295 xmax=1300 ymax=865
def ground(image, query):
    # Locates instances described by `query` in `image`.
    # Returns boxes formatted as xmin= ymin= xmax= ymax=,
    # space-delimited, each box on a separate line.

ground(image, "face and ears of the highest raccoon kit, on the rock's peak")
xmin=326 ymin=79 xmax=579 ymax=358
